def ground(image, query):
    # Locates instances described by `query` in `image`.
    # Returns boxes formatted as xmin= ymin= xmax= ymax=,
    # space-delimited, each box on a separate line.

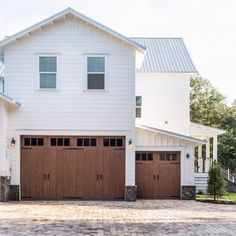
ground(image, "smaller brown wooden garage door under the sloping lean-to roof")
xmin=136 ymin=152 xmax=180 ymax=199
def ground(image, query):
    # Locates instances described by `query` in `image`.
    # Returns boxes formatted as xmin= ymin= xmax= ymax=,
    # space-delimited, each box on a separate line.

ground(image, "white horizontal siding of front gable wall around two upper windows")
xmin=4 ymin=19 xmax=135 ymax=185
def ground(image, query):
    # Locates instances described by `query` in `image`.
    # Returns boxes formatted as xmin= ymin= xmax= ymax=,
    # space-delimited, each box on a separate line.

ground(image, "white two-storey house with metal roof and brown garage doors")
xmin=0 ymin=8 xmax=225 ymax=201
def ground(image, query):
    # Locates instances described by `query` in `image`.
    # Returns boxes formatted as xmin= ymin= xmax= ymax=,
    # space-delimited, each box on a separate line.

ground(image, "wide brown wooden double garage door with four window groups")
xmin=21 ymin=136 xmax=125 ymax=200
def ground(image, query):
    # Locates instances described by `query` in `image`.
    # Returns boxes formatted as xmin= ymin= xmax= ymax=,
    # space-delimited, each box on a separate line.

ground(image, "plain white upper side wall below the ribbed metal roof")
xmin=136 ymin=73 xmax=190 ymax=135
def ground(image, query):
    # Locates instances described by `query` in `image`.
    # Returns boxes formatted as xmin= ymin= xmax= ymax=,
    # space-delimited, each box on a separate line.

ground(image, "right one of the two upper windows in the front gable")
xmin=87 ymin=57 xmax=105 ymax=90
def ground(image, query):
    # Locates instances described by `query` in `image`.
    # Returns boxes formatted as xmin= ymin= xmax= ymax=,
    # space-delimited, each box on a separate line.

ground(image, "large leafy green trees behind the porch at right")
xmin=190 ymin=77 xmax=236 ymax=170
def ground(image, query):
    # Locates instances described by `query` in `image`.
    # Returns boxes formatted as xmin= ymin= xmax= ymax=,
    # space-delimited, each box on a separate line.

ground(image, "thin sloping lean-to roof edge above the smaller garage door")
xmin=136 ymin=124 xmax=206 ymax=144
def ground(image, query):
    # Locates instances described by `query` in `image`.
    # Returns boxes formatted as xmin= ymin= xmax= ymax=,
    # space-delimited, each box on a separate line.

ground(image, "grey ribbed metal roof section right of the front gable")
xmin=131 ymin=38 xmax=197 ymax=73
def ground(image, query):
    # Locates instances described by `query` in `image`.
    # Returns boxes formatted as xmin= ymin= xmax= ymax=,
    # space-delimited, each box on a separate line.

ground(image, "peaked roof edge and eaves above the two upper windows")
xmin=0 ymin=7 xmax=145 ymax=52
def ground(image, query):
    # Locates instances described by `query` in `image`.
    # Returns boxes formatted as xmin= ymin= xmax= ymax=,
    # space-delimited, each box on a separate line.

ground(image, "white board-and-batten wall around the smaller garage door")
xmin=136 ymin=128 xmax=195 ymax=185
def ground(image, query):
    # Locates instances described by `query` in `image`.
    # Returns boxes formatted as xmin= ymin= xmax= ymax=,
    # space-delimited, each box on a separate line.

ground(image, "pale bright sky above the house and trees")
xmin=0 ymin=0 xmax=236 ymax=104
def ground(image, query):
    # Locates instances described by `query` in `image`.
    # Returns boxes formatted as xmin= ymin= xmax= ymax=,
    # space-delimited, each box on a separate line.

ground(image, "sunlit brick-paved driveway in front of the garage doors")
xmin=0 ymin=200 xmax=236 ymax=235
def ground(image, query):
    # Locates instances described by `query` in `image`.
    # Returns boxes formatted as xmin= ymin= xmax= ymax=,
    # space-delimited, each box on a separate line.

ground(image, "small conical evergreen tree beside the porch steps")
xmin=207 ymin=162 xmax=225 ymax=201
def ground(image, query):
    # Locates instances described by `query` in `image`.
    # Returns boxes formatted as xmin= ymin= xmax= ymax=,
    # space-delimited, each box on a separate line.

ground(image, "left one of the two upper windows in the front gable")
xmin=39 ymin=56 xmax=57 ymax=89
